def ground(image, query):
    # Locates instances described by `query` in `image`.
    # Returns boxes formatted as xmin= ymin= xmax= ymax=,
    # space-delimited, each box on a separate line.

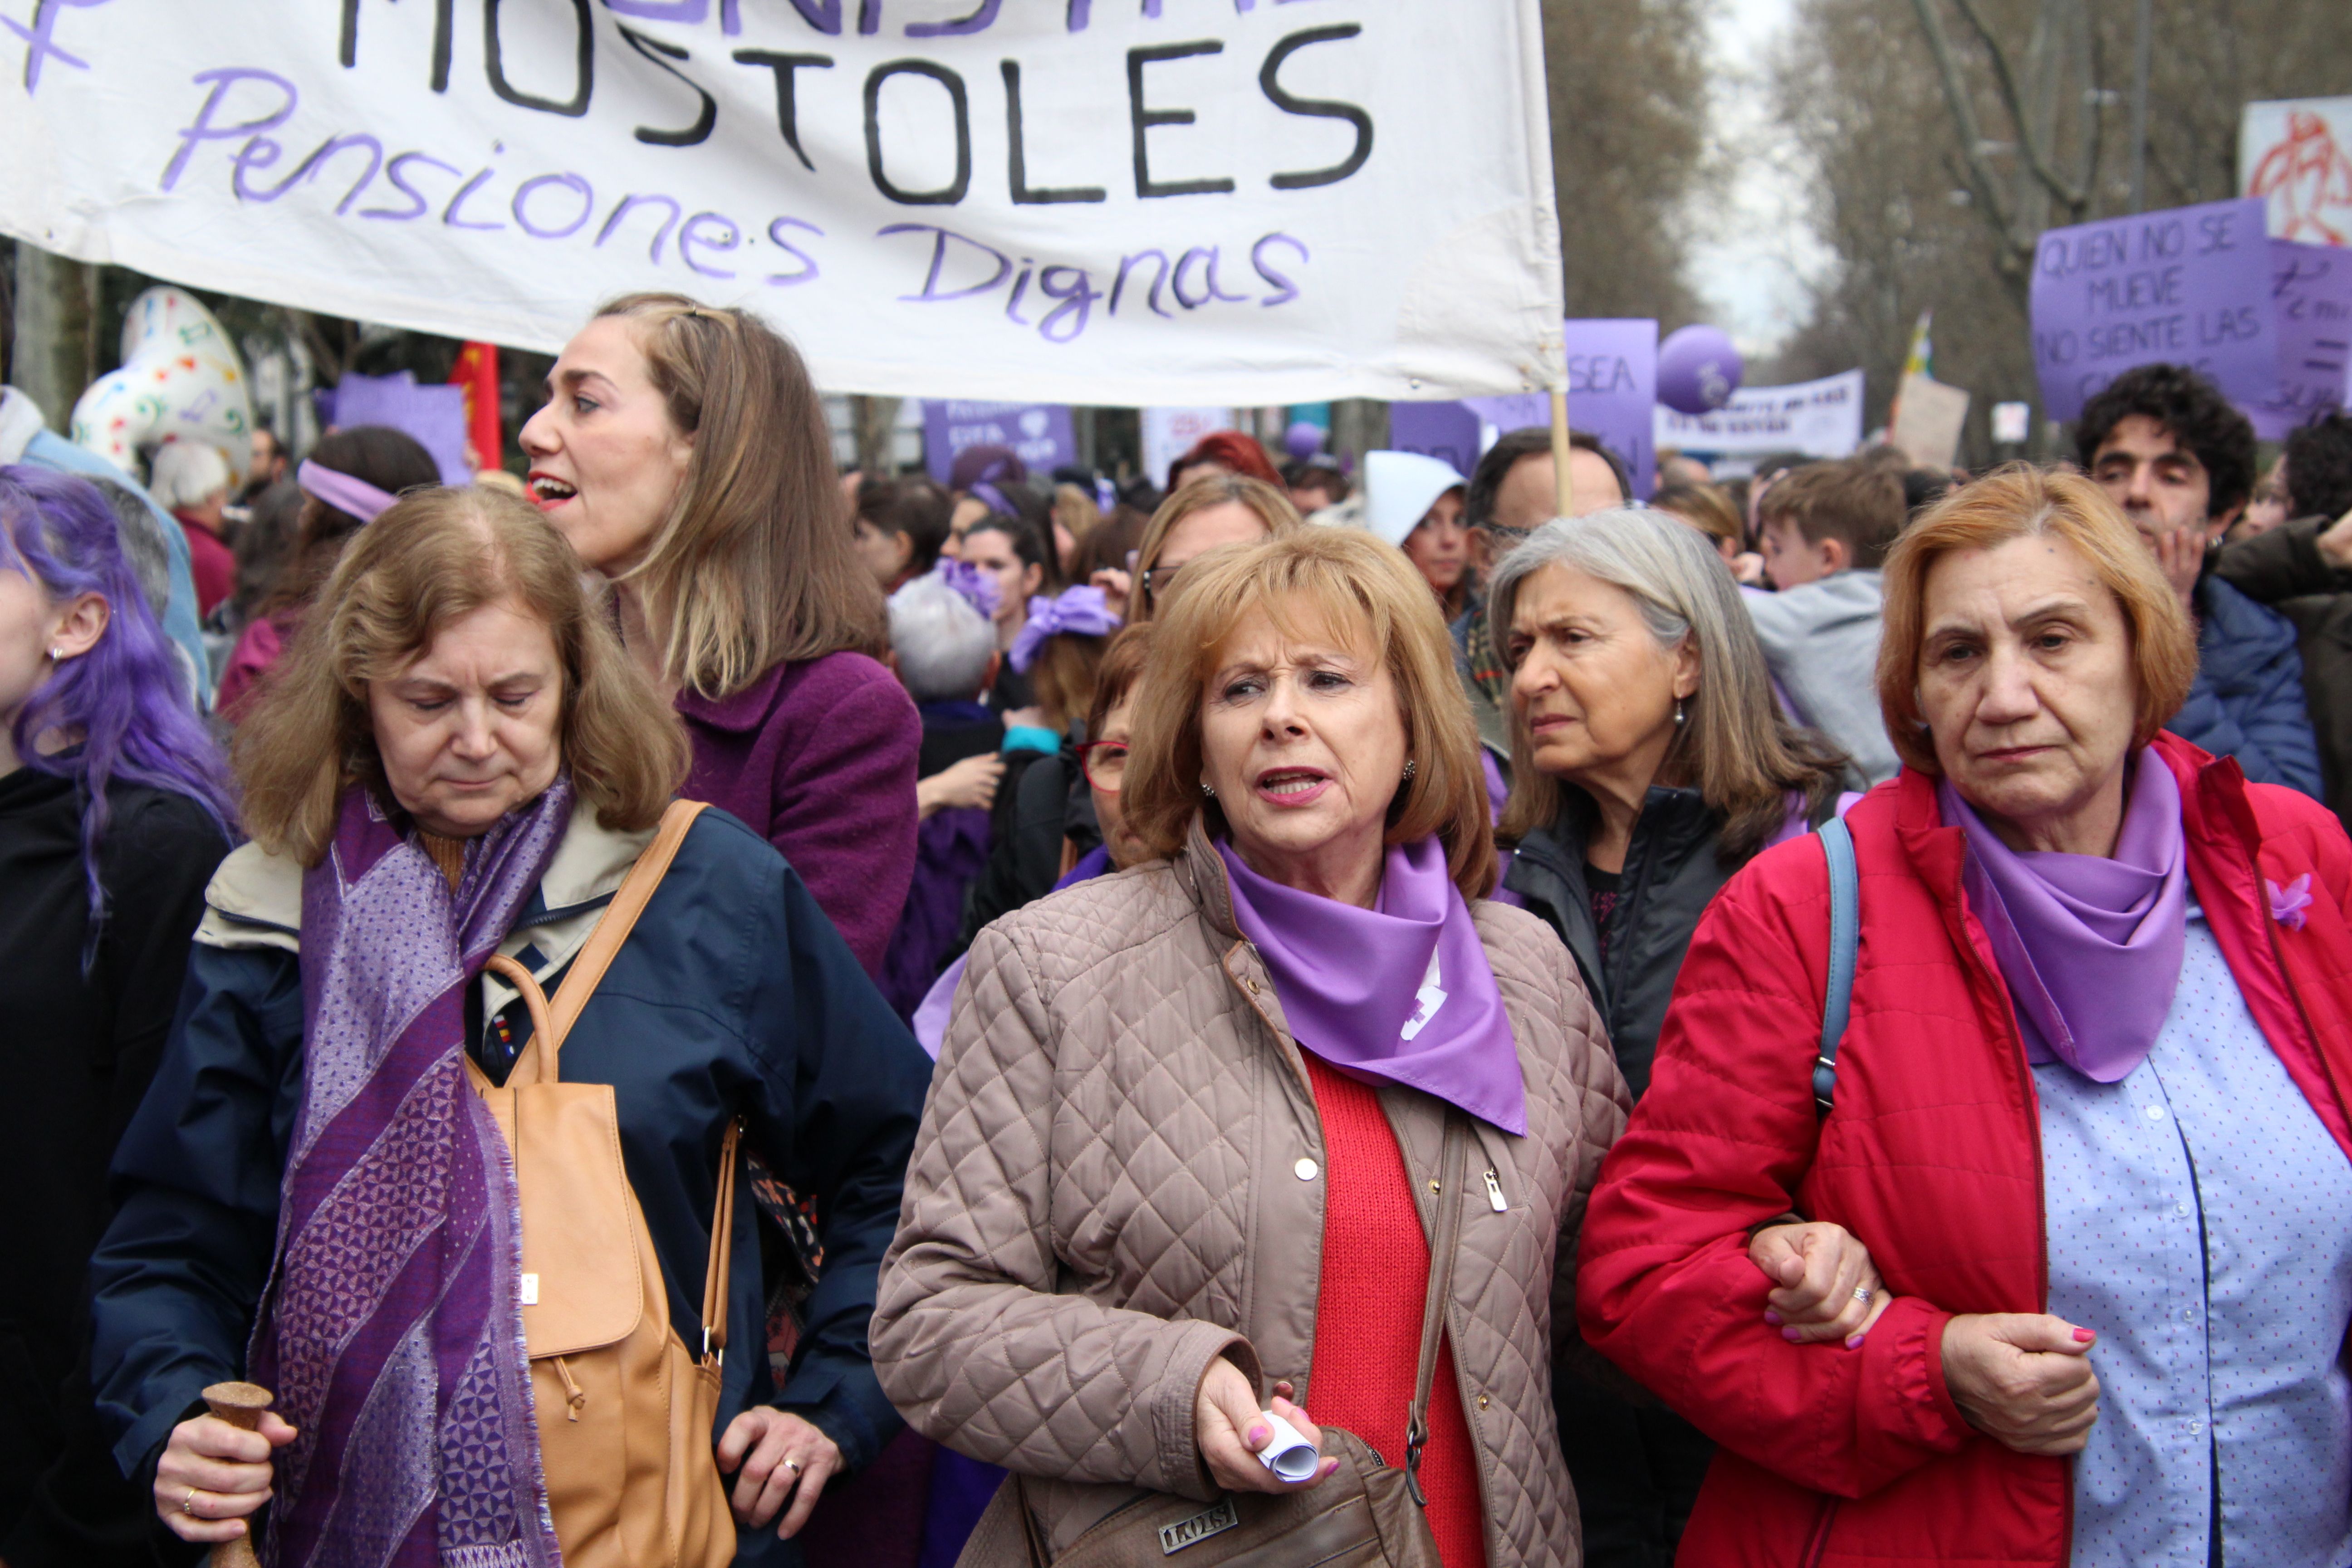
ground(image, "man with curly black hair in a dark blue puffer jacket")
xmin=2074 ymin=364 xmax=2322 ymax=794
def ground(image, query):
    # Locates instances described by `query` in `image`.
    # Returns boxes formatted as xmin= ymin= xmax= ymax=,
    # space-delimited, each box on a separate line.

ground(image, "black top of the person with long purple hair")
xmin=0 ymin=769 xmax=228 ymax=1568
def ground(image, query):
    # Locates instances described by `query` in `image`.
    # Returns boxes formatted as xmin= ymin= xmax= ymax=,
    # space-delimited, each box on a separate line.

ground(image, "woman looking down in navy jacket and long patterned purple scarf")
xmin=94 ymin=491 xmax=929 ymax=1563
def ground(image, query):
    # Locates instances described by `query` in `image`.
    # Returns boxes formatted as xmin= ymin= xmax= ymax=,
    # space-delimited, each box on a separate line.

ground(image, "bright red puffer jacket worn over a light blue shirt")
xmin=1576 ymin=736 xmax=2352 ymax=1568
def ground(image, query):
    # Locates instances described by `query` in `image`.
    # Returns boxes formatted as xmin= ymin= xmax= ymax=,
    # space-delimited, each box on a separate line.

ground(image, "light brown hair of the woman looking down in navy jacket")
xmin=233 ymin=487 xmax=687 ymax=865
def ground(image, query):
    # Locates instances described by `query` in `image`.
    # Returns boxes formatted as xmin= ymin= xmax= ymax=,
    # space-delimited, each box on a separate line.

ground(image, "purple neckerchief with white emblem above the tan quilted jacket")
xmin=1216 ymin=834 xmax=1526 ymax=1138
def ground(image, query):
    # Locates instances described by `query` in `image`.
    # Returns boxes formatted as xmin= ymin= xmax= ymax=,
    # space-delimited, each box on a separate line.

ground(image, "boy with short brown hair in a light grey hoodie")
xmin=1743 ymin=458 xmax=1907 ymax=783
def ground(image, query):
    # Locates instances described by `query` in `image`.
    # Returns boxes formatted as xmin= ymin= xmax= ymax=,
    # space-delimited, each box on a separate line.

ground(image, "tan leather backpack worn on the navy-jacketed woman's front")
xmin=468 ymin=802 xmax=741 ymax=1568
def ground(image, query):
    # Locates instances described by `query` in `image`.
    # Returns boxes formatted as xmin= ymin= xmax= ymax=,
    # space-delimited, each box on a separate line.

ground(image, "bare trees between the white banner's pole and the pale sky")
xmin=1543 ymin=0 xmax=1710 ymax=332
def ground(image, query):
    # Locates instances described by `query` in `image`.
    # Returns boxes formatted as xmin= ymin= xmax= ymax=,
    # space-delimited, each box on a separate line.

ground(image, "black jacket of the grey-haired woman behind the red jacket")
xmin=1503 ymin=788 xmax=1743 ymax=1100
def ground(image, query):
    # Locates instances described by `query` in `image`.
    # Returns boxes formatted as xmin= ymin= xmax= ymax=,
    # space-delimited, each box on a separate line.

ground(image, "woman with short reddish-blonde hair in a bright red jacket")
xmin=1578 ymin=468 xmax=2352 ymax=1566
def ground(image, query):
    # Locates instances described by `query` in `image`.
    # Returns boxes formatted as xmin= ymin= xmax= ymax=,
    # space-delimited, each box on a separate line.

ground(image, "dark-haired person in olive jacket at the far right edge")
xmin=2213 ymin=412 xmax=2352 ymax=828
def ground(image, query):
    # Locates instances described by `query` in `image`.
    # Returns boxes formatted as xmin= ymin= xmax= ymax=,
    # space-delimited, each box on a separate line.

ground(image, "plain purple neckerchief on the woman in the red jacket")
xmin=1936 ymin=750 xmax=2187 ymax=1084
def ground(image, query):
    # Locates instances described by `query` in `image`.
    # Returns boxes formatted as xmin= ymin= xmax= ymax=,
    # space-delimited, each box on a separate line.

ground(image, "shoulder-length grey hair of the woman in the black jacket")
xmin=1486 ymin=508 xmax=1844 ymax=858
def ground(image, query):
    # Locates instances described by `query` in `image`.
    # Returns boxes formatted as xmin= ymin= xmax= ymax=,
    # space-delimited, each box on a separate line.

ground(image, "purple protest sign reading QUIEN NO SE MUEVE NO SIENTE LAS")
xmin=2032 ymin=197 xmax=2279 ymax=418
